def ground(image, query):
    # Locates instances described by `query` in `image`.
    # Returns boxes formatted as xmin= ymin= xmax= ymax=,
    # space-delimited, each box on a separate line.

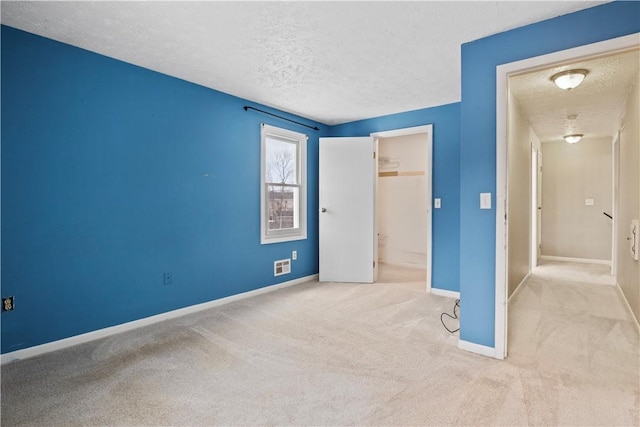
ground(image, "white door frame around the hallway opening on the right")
xmin=494 ymin=33 xmax=640 ymax=359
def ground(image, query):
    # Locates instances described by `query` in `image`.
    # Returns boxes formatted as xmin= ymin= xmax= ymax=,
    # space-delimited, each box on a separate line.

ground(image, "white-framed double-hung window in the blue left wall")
xmin=260 ymin=124 xmax=307 ymax=244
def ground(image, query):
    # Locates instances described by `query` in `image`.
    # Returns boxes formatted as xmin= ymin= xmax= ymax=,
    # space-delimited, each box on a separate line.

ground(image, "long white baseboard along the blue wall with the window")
xmin=0 ymin=274 xmax=318 ymax=365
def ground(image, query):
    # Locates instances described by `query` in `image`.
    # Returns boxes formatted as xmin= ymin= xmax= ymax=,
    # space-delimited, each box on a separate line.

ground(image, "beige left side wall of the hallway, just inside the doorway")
xmin=507 ymin=95 xmax=539 ymax=295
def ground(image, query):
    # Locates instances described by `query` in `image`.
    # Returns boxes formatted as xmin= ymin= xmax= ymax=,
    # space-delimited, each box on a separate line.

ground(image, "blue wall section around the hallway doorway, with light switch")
xmin=460 ymin=2 xmax=640 ymax=347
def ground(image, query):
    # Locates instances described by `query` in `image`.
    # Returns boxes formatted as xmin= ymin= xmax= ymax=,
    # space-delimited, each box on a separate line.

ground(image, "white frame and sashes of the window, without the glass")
xmin=260 ymin=123 xmax=308 ymax=245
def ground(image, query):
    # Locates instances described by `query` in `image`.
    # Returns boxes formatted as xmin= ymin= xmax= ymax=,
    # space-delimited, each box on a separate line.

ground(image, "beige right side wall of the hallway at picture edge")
xmin=617 ymin=72 xmax=640 ymax=319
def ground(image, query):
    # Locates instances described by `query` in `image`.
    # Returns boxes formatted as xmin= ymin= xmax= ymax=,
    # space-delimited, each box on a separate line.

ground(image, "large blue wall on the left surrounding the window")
xmin=1 ymin=26 xmax=328 ymax=353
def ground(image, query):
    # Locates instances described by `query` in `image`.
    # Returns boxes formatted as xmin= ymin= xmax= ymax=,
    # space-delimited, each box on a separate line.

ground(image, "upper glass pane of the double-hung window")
xmin=264 ymin=136 xmax=298 ymax=184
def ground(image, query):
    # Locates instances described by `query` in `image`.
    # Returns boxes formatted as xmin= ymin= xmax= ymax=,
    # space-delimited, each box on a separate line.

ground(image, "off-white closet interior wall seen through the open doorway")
xmin=377 ymin=134 xmax=428 ymax=268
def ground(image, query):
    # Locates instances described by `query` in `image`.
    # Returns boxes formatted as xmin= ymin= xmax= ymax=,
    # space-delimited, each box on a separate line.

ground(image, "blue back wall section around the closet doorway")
xmin=330 ymin=103 xmax=460 ymax=291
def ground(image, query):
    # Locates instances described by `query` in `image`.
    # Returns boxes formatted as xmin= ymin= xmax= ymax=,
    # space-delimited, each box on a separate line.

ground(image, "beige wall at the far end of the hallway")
xmin=541 ymin=137 xmax=613 ymax=261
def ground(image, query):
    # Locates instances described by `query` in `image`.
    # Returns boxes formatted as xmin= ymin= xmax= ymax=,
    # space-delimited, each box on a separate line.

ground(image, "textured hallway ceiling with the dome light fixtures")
xmin=509 ymin=49 xmax=640 ymax=141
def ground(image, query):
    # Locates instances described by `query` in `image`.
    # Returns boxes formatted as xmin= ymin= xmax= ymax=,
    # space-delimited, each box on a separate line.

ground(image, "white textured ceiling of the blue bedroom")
xmin=1 ymin=1 xmax=606 ymax=124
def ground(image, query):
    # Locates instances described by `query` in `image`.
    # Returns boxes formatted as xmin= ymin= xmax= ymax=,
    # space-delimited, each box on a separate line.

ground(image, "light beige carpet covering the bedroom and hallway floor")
xmin=2 ymin=265 xmax=640 ymax=426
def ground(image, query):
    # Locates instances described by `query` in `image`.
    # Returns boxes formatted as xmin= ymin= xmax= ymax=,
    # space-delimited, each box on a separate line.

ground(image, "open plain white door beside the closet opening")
xmin=318 ymin=137 xmax=377 ymax=283
